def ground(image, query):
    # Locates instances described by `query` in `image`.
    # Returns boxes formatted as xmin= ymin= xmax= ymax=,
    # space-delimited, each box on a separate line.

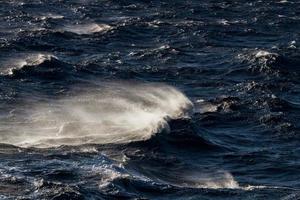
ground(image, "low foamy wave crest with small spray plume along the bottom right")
xmin=99 ymin=167 xmax=278 ymax=191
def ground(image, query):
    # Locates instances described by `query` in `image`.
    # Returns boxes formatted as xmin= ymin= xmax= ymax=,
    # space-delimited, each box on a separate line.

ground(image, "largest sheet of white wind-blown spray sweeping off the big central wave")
xmin=0 ymin=84 xmax=192 ymax=147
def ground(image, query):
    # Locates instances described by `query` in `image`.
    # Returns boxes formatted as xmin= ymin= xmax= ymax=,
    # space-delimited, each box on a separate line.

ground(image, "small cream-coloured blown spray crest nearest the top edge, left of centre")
xmin=62 ymin=23 xmax=112 ymax=35
